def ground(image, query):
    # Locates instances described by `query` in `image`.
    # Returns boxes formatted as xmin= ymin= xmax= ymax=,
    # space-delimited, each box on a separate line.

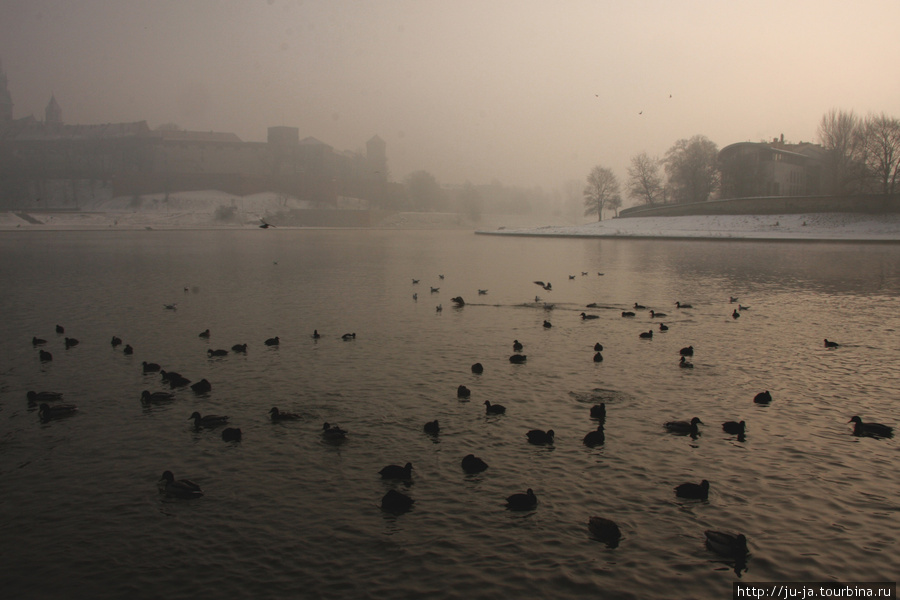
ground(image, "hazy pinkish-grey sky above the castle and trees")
xmin=0 ymin=0 xmax=900 ymax=189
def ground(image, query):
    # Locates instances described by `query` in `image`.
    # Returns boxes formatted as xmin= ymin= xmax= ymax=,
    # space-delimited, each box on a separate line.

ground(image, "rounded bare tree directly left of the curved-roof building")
xmin=665 ymin=135 xmax=719 ymax=202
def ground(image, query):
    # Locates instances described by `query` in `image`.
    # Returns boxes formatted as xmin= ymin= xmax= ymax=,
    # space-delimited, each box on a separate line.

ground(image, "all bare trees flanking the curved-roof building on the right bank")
xmin=583 ymin=109 xmax=900 ymax=220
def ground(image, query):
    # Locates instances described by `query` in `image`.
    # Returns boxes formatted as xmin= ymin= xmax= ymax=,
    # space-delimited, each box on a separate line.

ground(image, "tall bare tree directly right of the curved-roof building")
xmin=818 ymin=108 xmax=865 ymax=195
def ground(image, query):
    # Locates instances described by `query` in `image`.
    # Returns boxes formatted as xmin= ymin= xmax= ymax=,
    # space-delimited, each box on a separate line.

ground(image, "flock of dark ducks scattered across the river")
xmin=26 ymin=273 xmax=893 ymax=570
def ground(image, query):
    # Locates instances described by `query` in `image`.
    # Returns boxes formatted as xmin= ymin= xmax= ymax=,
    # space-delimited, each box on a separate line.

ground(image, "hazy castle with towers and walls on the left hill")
xmin=0 ymin=61 xmax=397 ymax=209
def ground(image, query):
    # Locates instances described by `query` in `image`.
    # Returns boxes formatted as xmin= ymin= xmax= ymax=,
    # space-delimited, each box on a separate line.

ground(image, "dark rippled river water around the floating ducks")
xmin=0 ymin=229 xmax=900 ymax=600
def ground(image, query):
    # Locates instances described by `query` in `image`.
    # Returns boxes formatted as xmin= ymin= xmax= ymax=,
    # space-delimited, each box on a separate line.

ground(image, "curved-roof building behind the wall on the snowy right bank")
xmin=719 ymin=136 xmax=830 ymax=198
